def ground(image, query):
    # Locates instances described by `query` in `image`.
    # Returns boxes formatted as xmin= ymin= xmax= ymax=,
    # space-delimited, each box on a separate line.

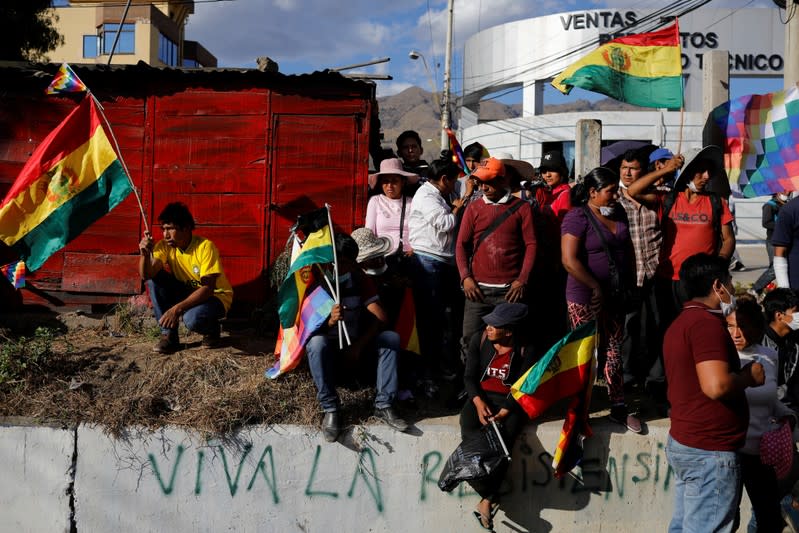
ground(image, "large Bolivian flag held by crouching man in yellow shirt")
xmin=0 ymin=96 xmax=133 ymax=271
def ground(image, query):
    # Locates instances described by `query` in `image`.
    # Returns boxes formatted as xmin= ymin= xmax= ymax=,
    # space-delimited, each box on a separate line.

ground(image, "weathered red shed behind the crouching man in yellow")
xmin=0 ymin=63 xmax=379 ymax=310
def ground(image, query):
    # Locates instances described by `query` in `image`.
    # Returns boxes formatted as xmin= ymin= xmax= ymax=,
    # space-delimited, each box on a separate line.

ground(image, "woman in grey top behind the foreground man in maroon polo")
xmin=722 ymin=296 xmax=796 ymax=533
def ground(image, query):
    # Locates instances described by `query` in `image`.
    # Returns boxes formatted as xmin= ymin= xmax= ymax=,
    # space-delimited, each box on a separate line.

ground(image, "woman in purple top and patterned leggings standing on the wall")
xmin=561 ymin=167 xmax=642 ymax=433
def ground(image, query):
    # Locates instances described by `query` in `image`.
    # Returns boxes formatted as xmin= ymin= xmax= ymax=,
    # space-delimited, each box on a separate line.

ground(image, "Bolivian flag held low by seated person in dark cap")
xmin=510 ymin=321 xmax=596 ymax=418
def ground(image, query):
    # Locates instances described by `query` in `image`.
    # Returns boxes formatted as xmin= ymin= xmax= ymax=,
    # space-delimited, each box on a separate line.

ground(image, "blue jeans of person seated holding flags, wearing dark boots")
xmin=305 ymin=328 xmax=399 ymax=412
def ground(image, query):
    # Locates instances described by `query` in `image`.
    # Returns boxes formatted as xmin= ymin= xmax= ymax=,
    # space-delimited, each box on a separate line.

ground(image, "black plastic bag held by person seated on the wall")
xmin=438 ymin=426 xmax=510 ymax=492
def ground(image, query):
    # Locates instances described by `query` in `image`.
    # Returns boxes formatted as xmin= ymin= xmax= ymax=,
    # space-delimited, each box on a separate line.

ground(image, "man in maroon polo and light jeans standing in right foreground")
xmin=663 ymin=254 xmax=765 ymax=533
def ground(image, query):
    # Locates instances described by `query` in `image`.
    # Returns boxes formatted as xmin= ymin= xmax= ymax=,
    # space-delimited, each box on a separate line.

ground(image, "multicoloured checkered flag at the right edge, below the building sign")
xmin=712 ymin=87 xmax=799 ymax=198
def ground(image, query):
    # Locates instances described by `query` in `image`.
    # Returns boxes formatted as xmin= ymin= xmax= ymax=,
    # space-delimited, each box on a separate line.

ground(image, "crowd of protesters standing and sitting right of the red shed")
xmin=282 ymin=132 xmax=799 ymax=531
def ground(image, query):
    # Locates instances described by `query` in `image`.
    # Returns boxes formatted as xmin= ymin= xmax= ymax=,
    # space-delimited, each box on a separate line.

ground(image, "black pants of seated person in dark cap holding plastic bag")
xmin=460 ymin=392 xmax=527 ymax=502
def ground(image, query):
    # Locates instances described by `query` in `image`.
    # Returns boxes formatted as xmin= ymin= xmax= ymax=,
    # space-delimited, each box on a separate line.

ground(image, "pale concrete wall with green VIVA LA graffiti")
xmin=0 ymin=417 xmax=749 ymax=533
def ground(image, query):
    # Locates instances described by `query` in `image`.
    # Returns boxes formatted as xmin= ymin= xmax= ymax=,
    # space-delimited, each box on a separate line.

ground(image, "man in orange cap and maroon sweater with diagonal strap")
xmin=455 ymin=157 xmax=535 ymax=353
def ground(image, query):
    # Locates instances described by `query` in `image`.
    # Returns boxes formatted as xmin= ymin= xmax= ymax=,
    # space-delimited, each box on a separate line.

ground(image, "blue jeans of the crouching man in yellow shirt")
xmin=147 ymin=270 xmax=225 ymax=342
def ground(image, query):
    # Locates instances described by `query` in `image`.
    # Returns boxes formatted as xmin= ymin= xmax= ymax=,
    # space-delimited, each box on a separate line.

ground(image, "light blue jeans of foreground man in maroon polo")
xmin=666 ymin=435 xmax=741 ymax=533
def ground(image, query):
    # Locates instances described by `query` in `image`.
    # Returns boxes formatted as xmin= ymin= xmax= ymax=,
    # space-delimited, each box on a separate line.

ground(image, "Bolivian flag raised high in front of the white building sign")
xmin=552 ymin=21 xmax=683 ymax=109
